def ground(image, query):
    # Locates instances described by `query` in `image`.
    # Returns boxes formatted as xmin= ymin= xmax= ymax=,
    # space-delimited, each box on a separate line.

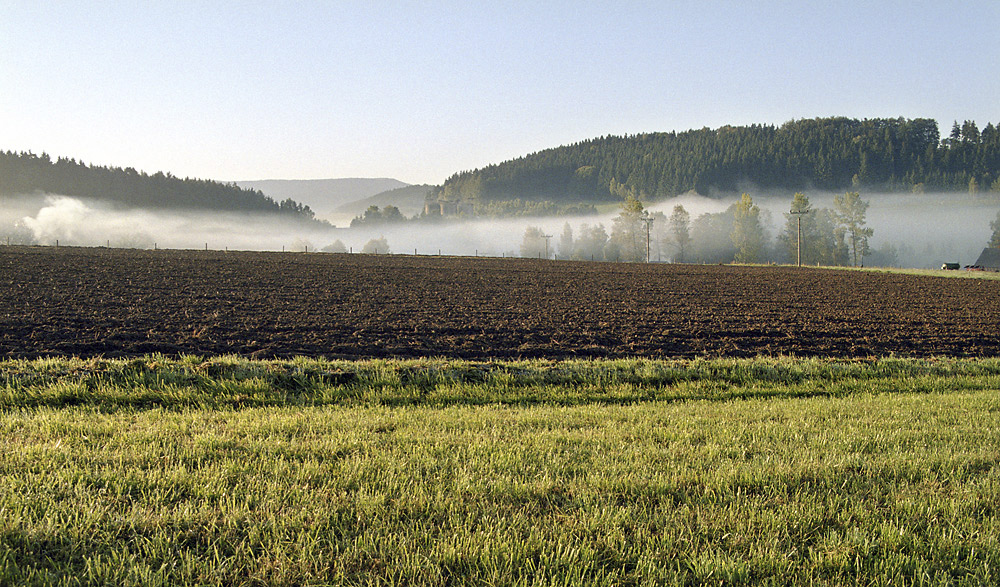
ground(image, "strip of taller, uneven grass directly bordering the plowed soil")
xmin=0 ymin=355 xmax=1000 ymax=410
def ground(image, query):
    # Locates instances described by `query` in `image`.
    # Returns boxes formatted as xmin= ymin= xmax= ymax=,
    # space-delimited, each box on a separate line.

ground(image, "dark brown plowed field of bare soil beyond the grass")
xmin=0 ymin=247 xmax=1000 ymax=359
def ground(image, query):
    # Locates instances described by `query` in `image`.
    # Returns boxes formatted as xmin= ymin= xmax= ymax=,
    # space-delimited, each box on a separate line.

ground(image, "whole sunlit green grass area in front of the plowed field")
xmin=0 ymin=357 xmax=1000 ymax=585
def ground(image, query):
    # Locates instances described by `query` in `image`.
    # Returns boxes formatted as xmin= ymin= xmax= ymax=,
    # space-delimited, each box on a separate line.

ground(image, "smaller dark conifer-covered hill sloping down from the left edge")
xmin=0 ymin=151 xmax=314 ymax=220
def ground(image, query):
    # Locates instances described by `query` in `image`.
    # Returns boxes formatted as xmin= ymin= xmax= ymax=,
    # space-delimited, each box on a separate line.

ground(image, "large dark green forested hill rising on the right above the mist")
xmin=431 ymin=118 xmax=1000 ymax=202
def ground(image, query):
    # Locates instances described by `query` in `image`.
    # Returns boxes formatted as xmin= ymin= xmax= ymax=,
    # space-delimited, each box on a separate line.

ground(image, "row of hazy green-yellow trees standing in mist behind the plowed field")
xmin=520 ymin=192 xmax=892 ymax=266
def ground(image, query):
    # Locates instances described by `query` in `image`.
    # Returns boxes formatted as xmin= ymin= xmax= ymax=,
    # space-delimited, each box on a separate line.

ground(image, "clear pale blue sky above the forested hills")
xmin=0 ymin=0 xmax=1000 ymax=183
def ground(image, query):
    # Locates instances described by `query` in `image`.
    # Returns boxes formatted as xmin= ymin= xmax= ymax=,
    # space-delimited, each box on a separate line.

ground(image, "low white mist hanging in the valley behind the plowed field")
xmin=0 ymin=192 xmax=1000 ymax=268
